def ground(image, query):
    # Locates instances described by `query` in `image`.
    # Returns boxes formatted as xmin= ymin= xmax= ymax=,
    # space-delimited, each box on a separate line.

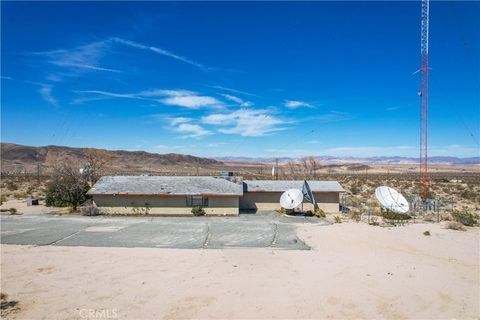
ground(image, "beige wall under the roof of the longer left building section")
xmin=93 ymin=195 xmax=239 ymax=215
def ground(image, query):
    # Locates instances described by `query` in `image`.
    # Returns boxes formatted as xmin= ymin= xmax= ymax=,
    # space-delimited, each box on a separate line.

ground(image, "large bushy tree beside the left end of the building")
xmin=45 ymin=164 xmax=90 ymax=211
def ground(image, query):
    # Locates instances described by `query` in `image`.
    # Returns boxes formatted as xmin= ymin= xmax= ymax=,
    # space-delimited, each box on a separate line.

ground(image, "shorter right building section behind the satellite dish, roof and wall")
xmin=240 ymin=180 xmax=345 ymax=213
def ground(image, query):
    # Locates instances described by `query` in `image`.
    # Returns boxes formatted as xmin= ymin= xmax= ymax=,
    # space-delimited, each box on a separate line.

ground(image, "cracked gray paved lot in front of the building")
xmin=0 ymin=214 xmax=327 ymax=250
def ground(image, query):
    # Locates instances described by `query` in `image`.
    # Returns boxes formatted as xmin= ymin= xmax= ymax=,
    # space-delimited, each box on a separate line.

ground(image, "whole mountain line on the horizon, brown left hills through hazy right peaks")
xmin=0 ymin=143 xmax=480 ymax=174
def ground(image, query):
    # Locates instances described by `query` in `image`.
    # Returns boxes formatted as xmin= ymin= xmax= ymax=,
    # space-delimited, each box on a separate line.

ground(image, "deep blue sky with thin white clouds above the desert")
xmin=1 ymin=2 xmax=480 ymax=157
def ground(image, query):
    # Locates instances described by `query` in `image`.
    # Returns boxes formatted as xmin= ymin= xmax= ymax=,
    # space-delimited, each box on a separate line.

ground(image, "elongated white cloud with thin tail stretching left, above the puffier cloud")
xmin=76 ymin=89 xmax=224 ymax=109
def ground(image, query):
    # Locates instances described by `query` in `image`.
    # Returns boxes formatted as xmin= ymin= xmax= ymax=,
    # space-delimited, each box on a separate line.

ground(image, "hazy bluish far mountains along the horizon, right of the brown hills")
xmin=215 ymin=156 xmax=480 ymax=164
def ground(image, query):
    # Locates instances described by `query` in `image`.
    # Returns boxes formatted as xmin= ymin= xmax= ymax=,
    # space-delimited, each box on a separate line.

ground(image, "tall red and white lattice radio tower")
xmin=418 ymin=0 xmax=429 ymax=200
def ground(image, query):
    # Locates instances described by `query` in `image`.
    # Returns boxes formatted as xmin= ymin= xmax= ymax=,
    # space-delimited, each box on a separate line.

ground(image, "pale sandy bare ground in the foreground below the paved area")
xmin=1 ymin=223 xmax=480 ymax=319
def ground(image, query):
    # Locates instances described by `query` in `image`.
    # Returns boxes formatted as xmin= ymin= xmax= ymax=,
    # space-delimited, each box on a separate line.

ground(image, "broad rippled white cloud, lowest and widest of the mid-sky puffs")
xmin=202 ymin=109 xmax=285 ymax=137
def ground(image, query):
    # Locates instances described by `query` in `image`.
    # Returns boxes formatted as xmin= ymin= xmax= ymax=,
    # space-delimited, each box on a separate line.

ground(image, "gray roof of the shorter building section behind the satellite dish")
xmin=243 ymin=180 xmax=345 ymax=192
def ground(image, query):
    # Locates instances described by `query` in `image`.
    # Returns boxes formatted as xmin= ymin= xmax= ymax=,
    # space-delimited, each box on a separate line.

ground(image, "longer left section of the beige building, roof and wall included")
xmin=88 ymin=176 xmax=243 ymax=215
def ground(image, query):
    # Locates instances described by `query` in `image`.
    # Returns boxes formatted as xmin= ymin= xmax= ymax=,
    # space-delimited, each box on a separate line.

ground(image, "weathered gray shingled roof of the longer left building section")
xmin=88 ymin=176 xmax=243 ymax=196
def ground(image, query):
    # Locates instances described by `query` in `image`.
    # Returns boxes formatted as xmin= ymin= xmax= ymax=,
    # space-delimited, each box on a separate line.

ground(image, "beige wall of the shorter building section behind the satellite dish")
xmin=240 ymin=192 xmax=340 ymax=213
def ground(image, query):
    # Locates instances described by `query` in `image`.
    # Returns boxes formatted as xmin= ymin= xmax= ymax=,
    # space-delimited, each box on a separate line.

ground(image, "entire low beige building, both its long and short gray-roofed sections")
xmin=88 ymin=176 xmax=345 ymax=215
